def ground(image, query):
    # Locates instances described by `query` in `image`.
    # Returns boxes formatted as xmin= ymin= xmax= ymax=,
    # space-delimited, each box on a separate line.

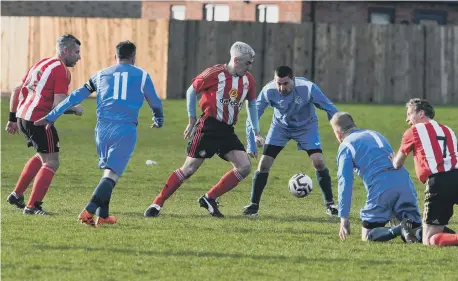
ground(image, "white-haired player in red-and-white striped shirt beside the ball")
xmin=144 ymin=42 xmax=264 ymax=217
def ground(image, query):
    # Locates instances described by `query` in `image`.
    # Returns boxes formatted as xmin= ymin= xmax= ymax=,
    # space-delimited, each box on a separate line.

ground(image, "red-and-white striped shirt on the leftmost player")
xmin=16 ymin=58 xmax=71 ymax=121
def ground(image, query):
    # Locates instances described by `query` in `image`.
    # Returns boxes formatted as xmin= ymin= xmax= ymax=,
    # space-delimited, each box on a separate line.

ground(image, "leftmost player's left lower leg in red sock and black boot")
xmin=7 ymin=154 xmax=42 ymax=209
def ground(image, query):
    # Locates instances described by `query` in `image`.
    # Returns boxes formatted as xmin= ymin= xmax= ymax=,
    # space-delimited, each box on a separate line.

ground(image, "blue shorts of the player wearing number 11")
xmin=95 ymin=120 xmax=137 ymax=176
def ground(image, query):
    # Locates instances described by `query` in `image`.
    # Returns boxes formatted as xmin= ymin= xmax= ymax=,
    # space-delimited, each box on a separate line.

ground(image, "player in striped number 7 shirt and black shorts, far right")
xmin=393 ymin=98 xmax=458 ymax=246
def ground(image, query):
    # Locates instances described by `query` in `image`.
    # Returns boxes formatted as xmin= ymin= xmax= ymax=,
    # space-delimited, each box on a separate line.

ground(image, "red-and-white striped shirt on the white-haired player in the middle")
xmin=192 ymin=64 xmax=256 ymax=125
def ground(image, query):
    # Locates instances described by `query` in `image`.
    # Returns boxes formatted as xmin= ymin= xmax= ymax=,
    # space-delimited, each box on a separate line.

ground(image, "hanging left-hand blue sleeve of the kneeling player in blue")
xmin=337 ymin=145 xmax=354 ymax=217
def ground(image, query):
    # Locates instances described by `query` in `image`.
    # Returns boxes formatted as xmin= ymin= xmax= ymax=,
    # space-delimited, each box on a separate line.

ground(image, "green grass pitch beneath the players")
xmin=1 ymin=99 xmax=458 ymax=281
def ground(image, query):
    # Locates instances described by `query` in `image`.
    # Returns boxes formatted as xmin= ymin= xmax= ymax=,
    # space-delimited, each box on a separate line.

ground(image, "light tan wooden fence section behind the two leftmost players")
xmin=1 ymin=17 xmax=169 ymax=98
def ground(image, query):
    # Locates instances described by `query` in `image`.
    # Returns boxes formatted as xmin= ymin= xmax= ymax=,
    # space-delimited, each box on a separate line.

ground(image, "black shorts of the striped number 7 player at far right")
xmin=423 ymin=169 xmax=458 ymax=225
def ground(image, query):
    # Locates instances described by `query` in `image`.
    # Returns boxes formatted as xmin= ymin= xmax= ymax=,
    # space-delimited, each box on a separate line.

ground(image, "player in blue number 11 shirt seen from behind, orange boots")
xmin=35 ymin=41 xmax=164 ymax=226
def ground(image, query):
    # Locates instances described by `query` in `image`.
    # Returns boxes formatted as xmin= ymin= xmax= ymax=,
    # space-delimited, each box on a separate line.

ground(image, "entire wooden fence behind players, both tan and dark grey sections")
xmin=1 ymin=17 xmax=458 ymax=105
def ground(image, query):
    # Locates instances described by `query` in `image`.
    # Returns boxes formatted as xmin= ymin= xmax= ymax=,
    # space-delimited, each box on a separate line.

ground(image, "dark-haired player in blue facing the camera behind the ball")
xmin=243 ymin=66 xmax=338 ymax=216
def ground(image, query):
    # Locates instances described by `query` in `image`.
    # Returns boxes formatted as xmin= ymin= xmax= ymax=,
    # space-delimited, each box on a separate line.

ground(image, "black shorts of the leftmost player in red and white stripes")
xmin=18 ymin=119 xmax=59 ymax=153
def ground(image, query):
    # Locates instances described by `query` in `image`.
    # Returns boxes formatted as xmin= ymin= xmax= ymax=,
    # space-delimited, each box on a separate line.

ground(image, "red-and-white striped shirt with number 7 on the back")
xmin=400 ymin=120 xmax=458 ymax=183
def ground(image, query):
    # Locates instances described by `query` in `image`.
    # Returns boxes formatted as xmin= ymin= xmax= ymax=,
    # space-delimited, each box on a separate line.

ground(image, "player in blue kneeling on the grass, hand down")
xmin=331 ymin=112 xmax=421 ymax=241
